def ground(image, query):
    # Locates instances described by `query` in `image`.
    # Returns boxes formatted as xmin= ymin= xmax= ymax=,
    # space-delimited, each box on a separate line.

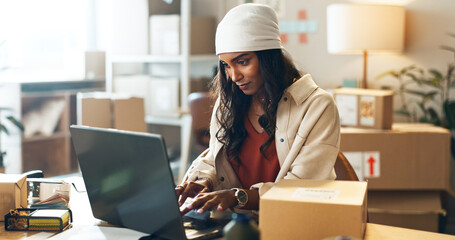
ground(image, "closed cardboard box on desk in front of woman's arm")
xmin=259 ymin=180 xmax=367 ymax=240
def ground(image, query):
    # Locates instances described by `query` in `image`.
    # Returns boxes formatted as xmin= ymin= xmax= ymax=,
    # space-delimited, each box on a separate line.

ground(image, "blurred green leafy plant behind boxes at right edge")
xmin=376 ymin=33 xmax=455 ymax=157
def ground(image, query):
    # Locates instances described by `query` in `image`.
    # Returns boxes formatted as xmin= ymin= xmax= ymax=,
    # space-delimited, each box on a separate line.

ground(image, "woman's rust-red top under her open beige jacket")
xmin=230 ymin=115 xmax=280 ymax=189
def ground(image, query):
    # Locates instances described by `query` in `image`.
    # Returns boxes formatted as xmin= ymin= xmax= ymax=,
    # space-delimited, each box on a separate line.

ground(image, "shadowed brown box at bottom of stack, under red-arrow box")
xmin=368 ymin=191 xmax=445 ymax=232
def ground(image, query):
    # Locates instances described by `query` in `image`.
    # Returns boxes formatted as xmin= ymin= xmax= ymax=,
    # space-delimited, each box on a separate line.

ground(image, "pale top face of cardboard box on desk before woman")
xmin=262 ymin=179 xmax=367 ymax=205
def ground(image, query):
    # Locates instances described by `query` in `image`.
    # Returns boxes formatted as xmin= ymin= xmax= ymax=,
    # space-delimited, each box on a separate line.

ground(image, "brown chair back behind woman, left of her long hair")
xmin=188 ymin=92 xmax=215 ymax=150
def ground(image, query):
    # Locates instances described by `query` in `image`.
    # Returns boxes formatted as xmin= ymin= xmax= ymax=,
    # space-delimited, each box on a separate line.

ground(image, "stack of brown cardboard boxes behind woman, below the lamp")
xmin=333 ymin=89 xmax=450 ymax=232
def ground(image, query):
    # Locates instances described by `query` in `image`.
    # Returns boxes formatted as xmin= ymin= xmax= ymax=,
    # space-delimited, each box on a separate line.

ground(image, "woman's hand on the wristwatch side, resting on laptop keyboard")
xmin=181 ymin=189 xmax=237 ymax=215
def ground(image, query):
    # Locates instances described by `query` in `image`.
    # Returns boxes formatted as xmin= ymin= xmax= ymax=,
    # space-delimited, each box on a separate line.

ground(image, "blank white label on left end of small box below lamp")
xmin=335 ymin=94 xmax=357 ymax=126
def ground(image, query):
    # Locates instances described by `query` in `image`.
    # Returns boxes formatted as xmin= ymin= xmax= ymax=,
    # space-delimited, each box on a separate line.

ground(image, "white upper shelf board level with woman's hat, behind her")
xmin=111 ymin=54 xmax=218 ymax=63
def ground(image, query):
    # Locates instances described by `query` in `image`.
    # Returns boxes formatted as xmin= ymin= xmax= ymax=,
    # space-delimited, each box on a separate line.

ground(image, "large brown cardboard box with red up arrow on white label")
xmin=340 ymin=123 xmax=450 ymax=190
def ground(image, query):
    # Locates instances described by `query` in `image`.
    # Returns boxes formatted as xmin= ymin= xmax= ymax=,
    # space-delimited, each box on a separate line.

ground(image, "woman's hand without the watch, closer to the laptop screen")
xmin=175 ymin=178 xmax=211 ymax=206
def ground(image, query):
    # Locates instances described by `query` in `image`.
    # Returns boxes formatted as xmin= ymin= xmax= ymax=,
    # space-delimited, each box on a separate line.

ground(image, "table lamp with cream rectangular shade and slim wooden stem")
xmin=327 ymin=4 xmax=405 ymax=88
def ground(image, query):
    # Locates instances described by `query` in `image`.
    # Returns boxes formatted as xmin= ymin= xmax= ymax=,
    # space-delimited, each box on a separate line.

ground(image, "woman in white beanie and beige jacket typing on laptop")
xmin=176 ymin=4 xmax=340 ymax=213
